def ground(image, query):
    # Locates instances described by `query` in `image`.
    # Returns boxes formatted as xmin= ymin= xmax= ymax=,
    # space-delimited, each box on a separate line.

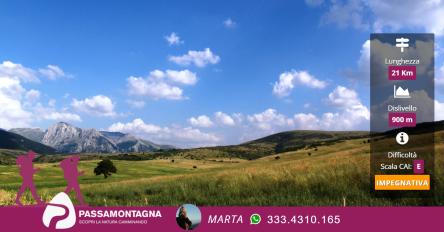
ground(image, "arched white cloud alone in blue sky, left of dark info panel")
xmin=273 ymin=70 xmax=327 ymax=97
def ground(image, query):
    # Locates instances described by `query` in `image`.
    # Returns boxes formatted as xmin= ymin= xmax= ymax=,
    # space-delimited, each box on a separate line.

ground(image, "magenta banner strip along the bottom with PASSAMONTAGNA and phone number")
xmin=0 ymin=206 xmax=444 ymax=232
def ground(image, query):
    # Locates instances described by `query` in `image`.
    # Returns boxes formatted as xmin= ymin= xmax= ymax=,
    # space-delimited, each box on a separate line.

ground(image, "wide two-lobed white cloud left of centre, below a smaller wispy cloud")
xmin=127 ymin=69 xmax=197 ymax=100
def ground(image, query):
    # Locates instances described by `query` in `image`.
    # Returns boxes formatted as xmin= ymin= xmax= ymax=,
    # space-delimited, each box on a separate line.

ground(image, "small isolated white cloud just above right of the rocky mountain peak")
xmin=71 ymin=95 xmax=116 ymax=117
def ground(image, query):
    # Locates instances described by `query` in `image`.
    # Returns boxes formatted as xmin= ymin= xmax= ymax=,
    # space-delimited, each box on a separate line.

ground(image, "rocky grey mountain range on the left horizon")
xmin=5 ymin=122 xmax=174 ymax=153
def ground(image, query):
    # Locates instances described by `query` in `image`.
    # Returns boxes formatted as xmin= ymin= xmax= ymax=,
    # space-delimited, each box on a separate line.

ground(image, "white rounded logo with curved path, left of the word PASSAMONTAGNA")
xmin=42 ymin=192 xmax=76 ymax=229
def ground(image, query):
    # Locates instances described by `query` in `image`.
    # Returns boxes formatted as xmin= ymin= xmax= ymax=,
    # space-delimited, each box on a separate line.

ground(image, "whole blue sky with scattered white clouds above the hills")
xmin=0 ymin=0 xmax=444 ymax=147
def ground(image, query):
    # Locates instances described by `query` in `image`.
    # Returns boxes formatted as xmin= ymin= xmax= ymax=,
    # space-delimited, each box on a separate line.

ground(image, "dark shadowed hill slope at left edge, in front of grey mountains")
xmin=0 ymin=129 xmax=56 ymax=154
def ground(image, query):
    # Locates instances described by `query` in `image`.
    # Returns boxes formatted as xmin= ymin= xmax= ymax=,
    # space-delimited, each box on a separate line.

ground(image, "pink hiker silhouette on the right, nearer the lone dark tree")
xmin=60 ymin=156 xmax=86 ymax=205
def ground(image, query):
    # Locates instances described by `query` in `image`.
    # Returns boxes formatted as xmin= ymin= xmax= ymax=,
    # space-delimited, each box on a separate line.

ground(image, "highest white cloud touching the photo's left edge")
xmin=0 ymin=61 xmax=39 ymax=82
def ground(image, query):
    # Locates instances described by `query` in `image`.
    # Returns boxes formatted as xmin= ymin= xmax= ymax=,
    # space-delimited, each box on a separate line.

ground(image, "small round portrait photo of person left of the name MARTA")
xmin=176 ymin=204 xmax=202 ymax=230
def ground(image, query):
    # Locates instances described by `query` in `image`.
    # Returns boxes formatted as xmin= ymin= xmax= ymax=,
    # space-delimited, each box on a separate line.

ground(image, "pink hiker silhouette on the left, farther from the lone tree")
xmin=15 ymin=151 xmax=44 ymax=205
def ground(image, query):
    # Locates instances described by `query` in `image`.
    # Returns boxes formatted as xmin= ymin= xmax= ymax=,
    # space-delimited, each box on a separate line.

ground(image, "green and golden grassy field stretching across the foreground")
xmin=0 ymin=132 xmax=444 ymax=206
